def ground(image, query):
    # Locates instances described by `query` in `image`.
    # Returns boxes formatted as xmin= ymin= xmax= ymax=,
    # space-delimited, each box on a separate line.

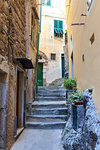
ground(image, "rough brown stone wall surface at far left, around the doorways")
xmin=0 ymin=0 xmax=26 ymax=150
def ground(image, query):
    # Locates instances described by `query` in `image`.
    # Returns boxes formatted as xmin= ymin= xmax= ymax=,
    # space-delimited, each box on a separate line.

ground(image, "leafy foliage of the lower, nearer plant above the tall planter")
xmin=68 ymin=92 xmax=83 ymax=104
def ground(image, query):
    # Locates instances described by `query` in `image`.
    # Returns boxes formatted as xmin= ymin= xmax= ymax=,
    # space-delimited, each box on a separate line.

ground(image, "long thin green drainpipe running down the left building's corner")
xmin=36 ymin=0 xmax=42 ymax=93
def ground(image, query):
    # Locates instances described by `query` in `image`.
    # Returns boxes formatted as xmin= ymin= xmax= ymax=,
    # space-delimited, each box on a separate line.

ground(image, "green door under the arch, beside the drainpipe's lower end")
xmin=38 ymin=63 xmax=43 ymax=86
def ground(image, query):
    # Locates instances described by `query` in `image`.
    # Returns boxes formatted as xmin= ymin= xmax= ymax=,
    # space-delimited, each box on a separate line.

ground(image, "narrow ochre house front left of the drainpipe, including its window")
xmin=26 ymin=0 xmax=41 ymax=102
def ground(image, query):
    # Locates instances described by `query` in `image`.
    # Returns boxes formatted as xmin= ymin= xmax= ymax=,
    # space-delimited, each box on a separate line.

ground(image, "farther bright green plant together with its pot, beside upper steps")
xmin=64 ymin=78 xmax=77 ymax=99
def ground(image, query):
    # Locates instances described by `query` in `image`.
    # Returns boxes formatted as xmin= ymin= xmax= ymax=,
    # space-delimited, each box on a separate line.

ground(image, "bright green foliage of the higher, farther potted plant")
xmin=64 ymin=78 xmax=77 ymax=90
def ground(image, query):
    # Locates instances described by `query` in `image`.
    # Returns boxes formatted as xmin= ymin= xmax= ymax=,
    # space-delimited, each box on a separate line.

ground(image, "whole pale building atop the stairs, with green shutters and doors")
xmin=38 ymin=0 xmax=67 ymax=86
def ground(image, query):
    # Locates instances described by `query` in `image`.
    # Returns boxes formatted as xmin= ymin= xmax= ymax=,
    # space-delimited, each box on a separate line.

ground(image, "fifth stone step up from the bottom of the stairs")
xmin=35 ymin=96 xmax=66 ymax=101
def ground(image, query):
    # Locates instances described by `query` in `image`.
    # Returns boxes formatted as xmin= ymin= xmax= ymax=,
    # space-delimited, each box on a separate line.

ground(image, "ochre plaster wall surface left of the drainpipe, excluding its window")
xmin=26 ymin=0 xmax=40 ymax=103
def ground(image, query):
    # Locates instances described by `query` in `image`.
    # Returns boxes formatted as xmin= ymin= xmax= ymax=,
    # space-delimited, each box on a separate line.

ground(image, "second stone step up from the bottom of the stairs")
xmin=26 ymin=115 xmax=68 ymax=122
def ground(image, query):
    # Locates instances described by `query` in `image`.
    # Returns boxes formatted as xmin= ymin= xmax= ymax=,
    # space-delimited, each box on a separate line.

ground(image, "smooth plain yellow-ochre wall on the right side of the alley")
xmin=66 ymin=0 xmax=100 ymax=114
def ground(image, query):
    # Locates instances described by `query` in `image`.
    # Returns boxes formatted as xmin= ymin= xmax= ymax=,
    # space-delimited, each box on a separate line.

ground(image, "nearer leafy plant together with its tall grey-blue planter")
xmin=68 ymin=92 xmax=84 ymax=130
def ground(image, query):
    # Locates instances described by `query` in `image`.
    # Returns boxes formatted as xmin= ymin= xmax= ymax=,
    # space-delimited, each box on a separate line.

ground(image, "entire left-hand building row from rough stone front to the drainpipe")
xmin=0 ymin=0 xmax=40 ymax=150
